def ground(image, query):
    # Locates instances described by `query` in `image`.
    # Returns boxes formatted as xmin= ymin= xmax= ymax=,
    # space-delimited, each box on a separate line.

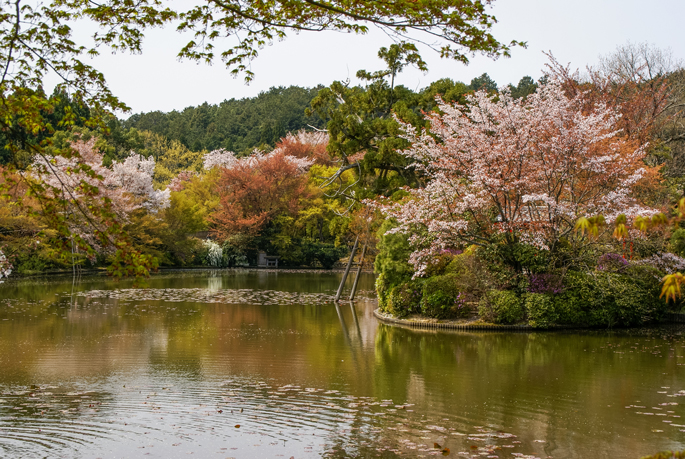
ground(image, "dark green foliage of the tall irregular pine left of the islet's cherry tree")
xmin=308 ymin=52 xmax=468 ymax=197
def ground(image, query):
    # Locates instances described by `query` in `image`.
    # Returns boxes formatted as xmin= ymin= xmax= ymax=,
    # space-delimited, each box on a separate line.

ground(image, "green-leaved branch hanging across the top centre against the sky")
xmin=178 ymin=0 xmax=525 ymax=82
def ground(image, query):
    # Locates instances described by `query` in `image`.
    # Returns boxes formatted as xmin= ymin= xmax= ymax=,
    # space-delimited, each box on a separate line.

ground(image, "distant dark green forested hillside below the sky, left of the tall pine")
xmin=123 ymin=86 xmax=324 ymax=153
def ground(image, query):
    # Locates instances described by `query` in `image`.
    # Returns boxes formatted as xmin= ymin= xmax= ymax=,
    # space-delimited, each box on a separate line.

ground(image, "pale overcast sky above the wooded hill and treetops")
xmin=84 ymin=0 xmax=685 ymax=117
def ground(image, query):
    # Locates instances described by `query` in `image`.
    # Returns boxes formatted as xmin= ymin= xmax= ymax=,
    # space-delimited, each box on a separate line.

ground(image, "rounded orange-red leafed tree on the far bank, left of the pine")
xmin=211 ymin=153 xmax=307 ymax=239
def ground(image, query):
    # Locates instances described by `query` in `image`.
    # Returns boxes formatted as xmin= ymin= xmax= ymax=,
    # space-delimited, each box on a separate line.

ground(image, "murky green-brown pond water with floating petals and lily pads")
xmin=0 ymin=271 xmax=685 ymax=459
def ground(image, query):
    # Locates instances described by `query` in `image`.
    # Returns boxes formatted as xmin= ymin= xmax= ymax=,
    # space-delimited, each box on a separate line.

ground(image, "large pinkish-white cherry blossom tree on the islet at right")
xmin=376 ymin=80 xmax=655 ymax=275
